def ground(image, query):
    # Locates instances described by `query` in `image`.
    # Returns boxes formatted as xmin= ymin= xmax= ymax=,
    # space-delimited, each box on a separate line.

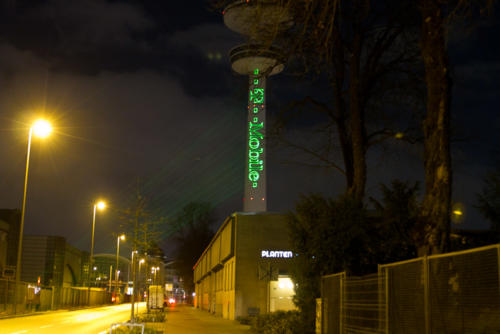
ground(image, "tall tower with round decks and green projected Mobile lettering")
xmin=223 ymin=0 xmax=292 ymax=212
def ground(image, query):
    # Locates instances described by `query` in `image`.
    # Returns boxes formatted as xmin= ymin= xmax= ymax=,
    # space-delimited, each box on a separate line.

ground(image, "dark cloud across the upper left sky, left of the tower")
xmin=0 ymin=0 xmax=234 ymax=96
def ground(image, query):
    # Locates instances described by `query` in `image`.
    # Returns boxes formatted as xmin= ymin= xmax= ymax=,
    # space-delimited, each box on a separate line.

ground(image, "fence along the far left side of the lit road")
xmin=0 ymin=279 xmax=111 ymax=317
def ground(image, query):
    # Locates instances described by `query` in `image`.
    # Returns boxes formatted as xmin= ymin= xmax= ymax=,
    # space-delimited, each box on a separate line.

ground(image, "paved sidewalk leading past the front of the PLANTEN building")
xmin=165 ymin=305 xmax=252 ymax=334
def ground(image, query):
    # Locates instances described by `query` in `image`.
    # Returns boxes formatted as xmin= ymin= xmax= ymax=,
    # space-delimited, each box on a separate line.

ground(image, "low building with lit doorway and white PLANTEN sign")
xmin=194 ymin=213 xmax=295 ymax=319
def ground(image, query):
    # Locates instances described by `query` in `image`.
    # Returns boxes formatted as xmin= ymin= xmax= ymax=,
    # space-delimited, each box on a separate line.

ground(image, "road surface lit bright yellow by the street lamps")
xmin=0 ymin=303 xmax=146 ymax=334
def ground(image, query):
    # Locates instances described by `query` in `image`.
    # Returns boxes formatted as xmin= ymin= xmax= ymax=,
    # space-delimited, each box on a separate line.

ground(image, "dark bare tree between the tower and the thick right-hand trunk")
xmin=266 ymin=0 xmax=420 ymax=200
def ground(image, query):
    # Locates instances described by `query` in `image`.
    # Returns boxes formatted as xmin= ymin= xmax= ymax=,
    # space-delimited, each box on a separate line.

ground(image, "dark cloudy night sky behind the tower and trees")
xmin=0 ymin=0 xmax=500 ymax=253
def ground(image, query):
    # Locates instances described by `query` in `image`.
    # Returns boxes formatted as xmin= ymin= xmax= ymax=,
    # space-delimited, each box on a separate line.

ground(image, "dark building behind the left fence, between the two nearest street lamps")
xmin=21 ymin=235 xmax=88 ymax=287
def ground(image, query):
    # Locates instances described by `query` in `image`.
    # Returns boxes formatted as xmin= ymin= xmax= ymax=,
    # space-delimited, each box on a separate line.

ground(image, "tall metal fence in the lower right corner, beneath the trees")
xmin=319 ymin=245 xmax=500 ymax=334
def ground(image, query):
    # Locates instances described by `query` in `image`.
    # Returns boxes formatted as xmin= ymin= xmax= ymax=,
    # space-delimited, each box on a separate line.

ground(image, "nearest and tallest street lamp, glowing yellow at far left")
xmin=14 ymin=119 xmax=52 ymax=313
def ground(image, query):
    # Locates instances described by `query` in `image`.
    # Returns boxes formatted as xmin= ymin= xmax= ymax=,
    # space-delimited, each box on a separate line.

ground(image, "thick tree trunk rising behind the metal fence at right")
xmin=419 ymin=0 xmax=452 ymax=254
